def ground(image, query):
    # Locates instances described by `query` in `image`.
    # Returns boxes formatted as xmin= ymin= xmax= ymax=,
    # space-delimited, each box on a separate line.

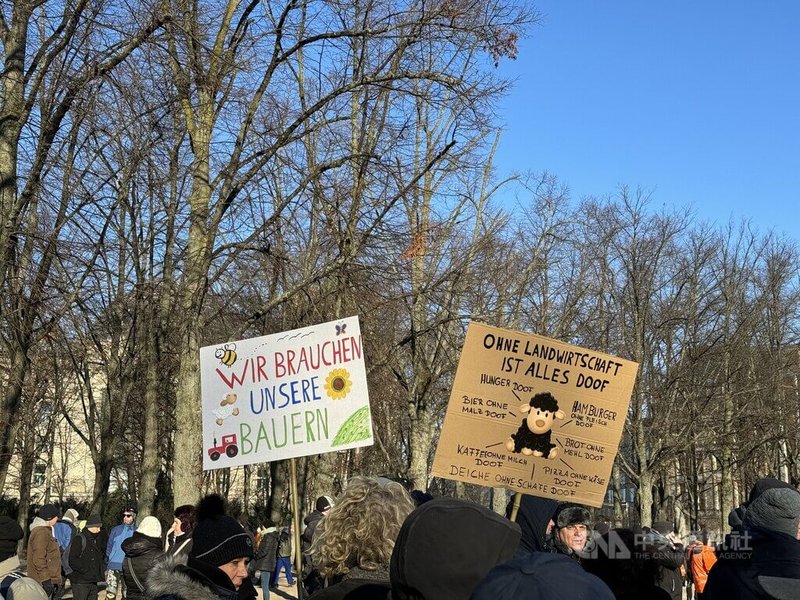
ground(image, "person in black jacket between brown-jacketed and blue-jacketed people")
xmin=69 ymin=514 xmax=106 ymax=600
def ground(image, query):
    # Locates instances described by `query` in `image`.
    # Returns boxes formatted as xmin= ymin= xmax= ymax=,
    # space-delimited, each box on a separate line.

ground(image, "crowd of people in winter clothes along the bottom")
xmin=0 ymin=477 xmax=800 ymax=600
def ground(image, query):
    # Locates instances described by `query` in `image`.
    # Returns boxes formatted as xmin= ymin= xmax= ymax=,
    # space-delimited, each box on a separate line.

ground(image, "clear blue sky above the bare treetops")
xmin=495 ymin=0 xmax=800 ymax=243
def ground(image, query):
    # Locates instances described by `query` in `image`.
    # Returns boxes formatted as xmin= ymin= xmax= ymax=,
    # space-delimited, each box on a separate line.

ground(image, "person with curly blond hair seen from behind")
xmin=310 ymin=477 xmax=414 ymax=600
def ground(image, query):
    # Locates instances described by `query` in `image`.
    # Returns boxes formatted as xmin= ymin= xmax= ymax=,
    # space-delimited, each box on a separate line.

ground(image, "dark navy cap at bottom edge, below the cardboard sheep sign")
xmin=470 ymin=552 xmax=614 ymax=600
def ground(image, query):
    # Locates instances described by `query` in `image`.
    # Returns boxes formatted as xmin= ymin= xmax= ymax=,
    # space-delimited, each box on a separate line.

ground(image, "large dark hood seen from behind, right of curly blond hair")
xmin=389 ymin=498 xmax=522 ymax=600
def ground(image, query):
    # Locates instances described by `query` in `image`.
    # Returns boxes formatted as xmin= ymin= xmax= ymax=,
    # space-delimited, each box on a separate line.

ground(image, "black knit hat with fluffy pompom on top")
xmin=189 ymin=494 xmax=253 ymax=567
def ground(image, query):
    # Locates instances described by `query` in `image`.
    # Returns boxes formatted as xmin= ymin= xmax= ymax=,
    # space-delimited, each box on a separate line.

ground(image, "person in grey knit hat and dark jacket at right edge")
xmin=703 ymin=487 xmax=800 ymax=600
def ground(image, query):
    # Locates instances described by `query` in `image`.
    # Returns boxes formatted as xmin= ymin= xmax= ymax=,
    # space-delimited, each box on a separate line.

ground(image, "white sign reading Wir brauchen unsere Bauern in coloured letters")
xmin=200 ymin=317 xmax=372 ymax=469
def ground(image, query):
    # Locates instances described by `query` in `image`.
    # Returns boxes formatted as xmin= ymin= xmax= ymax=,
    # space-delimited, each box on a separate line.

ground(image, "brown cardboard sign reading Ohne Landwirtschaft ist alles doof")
xmin=432 ymin=322 xmax=639 ymax=507
